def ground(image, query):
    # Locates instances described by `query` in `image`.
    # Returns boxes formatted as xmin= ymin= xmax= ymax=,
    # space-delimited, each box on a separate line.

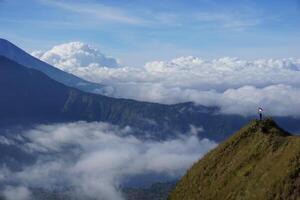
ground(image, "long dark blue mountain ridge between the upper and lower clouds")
xmin=0 ymin=56 xmax=300 ymax=141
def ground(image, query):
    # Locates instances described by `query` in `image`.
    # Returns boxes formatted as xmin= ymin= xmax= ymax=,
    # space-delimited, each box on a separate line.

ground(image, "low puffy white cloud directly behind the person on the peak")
xmin=219 ymin=84 xmax=300 ymax=116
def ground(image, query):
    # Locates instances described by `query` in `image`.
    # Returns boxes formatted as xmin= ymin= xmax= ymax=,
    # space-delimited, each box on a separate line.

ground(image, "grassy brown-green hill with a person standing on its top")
xmin=169 ymin=118 xmax=300 ymax=200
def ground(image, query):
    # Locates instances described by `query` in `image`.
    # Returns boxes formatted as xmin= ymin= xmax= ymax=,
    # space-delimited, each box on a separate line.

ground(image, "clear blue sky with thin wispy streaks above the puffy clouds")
xmin=0 ymin=0 xmax=300 ymax=66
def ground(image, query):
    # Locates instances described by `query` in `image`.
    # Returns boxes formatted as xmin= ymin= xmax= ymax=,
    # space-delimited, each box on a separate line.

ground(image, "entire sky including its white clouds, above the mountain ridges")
xmin=0 ymin=0 xmax=300 ymax=117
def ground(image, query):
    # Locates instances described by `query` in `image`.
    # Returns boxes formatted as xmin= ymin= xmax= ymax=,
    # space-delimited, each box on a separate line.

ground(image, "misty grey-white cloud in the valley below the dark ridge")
xmin=1 ymin=122 xmax=216 ymax=200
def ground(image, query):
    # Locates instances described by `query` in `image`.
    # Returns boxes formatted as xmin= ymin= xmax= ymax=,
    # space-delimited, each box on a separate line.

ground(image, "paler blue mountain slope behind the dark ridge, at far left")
xmin=0 ymin=38 xmax=103 ymax=93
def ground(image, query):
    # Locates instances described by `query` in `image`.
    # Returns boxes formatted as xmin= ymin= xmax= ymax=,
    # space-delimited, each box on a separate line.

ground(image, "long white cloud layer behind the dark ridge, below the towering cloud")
xmin=31 ymin=43 xmax=300 ymax=116
